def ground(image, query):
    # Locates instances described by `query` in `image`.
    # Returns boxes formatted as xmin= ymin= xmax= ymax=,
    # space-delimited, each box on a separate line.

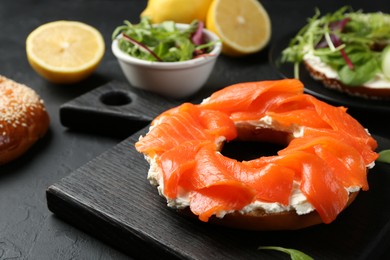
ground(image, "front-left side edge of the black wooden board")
xmin=46 ymin=183 xmax=184 ymax=260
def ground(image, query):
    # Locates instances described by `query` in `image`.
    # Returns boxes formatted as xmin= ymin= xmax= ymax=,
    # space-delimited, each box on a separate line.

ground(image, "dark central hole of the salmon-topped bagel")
xmin=221 ymin=140 xmax=286 ymax=162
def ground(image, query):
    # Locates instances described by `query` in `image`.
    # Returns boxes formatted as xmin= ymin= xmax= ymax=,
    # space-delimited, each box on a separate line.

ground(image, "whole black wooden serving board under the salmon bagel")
xmin=46 ymin=82 xmax=390 ymax=259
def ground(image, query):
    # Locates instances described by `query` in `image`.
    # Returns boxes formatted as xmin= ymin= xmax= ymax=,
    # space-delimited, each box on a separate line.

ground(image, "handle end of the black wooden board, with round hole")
xmin=60 ymin=81 xmax=179 ymax=137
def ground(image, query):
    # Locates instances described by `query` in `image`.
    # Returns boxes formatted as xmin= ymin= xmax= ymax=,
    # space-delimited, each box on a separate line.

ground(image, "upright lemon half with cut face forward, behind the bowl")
xmin=206 ymin=0 xmax=271 ymax=56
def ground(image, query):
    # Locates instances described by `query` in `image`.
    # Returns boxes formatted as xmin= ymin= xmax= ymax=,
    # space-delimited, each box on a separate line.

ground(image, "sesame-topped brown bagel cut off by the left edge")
xmin=0 ymin=76 xmax=49 ymax=165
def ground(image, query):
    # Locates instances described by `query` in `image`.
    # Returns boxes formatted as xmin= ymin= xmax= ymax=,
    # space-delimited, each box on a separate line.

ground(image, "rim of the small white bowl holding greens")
xmin=111 ymin=23 xmax=222 ymax=69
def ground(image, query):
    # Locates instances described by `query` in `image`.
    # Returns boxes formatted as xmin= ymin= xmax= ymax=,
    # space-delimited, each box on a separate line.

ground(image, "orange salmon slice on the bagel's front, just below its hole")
xmin=187 ymin=146 xmax=294 ymax=221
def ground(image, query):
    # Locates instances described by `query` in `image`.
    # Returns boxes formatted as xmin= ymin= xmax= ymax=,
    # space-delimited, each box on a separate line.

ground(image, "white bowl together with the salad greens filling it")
xmin=111 ymin=18 xmax=222 ymax=99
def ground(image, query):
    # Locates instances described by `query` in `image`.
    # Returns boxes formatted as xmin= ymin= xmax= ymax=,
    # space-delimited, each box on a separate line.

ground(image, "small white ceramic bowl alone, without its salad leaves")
xmin=111 ymin=24 xmax=222 ymax=99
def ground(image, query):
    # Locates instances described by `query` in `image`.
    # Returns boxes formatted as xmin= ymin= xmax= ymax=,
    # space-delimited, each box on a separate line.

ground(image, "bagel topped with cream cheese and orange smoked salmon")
xmin=135 ymin=79 xmax=378 ymax=230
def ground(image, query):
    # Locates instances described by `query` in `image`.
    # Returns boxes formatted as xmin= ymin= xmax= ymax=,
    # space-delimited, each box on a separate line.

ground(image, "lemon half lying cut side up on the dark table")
xmin=26 ymin=21 xmax=105 ymax=84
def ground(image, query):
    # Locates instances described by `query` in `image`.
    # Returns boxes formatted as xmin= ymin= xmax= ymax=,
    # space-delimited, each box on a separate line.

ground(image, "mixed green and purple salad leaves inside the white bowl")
xmin=112 ymin=17 xmax=215 ymax=62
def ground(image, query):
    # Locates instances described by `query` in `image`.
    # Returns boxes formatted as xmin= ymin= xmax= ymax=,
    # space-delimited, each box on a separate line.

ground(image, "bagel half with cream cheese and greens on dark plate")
xmin=281 ymin=6 xmax=390 ymax=99
